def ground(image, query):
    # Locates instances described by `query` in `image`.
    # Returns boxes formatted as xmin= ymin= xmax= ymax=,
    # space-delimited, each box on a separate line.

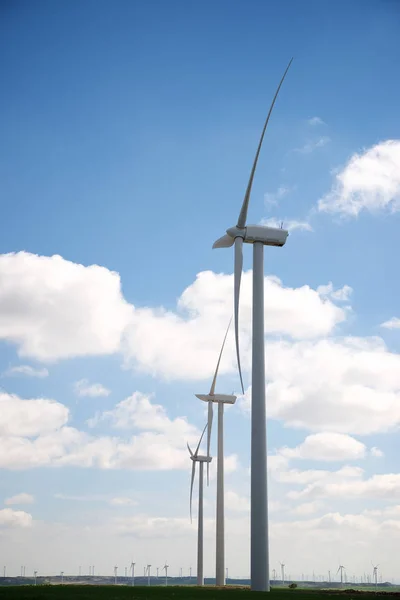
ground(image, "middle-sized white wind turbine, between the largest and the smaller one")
xmin=196 ymin=321 xmax=236 ymax=585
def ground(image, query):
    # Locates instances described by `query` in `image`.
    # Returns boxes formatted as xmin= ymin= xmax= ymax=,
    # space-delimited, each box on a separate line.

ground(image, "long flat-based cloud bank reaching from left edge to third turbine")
xmin=0 ymin=392 xmax=202 ymax=470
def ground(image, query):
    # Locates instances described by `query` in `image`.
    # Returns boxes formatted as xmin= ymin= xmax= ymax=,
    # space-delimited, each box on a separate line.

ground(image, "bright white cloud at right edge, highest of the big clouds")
xmin=318 ymin=140 xmax=400 ymax=217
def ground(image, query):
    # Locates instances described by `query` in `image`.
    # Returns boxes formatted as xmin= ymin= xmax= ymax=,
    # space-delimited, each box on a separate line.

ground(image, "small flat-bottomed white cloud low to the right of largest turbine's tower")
xmin=279 ymin=432 xmax=367 ymax=461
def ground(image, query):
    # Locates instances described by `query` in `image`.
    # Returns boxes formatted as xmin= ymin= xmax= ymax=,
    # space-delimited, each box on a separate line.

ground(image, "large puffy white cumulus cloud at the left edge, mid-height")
xmin=0 ymin=252 xmax=132 ymax=361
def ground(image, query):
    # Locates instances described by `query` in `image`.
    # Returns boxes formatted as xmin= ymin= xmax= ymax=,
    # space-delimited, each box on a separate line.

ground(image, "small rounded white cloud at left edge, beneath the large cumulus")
xmin=0 ymin=392 xmax=69 ymax=438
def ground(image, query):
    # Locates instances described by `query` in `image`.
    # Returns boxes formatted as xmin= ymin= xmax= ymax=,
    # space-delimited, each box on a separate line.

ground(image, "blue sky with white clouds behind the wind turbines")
xmin=0 ymin=0 xmax=400 ymax=578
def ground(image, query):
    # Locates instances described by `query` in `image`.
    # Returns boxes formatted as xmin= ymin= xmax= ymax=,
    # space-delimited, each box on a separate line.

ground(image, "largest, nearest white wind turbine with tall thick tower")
xmin=213 ymin=59 xmax=293 ymax=591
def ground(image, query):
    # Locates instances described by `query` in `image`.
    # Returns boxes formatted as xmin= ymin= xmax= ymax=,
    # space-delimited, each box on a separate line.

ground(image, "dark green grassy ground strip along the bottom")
xmin=0 ymin=585 xmax=398 ymax=600
